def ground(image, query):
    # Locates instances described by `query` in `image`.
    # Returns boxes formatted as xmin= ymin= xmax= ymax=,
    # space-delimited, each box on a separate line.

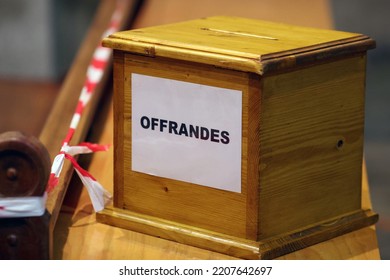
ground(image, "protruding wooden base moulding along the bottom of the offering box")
xmin=96 ymin=207 xmax=378 ymax=259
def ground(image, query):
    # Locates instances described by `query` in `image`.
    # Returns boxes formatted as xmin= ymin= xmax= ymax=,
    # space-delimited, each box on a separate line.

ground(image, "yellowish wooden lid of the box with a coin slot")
xmin=103 ymin=16 xmax=375 ymax=74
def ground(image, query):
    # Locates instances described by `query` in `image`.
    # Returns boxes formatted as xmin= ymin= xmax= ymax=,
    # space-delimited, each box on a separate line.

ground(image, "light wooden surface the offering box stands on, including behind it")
xmin=53 ymin=0 xmax=379 ymax=259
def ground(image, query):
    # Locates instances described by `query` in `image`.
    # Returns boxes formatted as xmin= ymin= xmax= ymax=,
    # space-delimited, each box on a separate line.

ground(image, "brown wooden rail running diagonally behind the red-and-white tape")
xmin=39 ymin=0 xmax=139 ymax=231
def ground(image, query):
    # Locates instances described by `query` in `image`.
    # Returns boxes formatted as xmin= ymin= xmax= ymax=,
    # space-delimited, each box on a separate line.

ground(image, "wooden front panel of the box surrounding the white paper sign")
xmin=114 ymin=54 xmax=253 ymax=239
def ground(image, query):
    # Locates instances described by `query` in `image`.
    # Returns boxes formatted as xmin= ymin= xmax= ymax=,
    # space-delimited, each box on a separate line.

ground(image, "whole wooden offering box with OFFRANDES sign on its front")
xmin=98 ymin=17 xmax=378 ymax=259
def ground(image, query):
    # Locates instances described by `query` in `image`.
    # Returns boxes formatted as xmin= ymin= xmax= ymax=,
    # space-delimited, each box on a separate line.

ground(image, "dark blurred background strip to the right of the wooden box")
xmin=331 ymin=0 xmax=390 ymax=259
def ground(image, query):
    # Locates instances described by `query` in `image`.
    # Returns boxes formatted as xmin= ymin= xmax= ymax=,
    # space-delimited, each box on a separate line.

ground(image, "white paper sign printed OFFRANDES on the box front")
xmin=132 ymin=73 xmax=242 ymax=192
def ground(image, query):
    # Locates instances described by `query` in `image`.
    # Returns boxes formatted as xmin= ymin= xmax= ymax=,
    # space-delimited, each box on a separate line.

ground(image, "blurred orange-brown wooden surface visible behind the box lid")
xmin=134 ymin=0 xmax=332 ymax=28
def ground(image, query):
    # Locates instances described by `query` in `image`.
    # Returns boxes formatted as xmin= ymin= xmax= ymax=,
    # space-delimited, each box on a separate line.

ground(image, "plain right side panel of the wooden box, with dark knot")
xmin=259 ymin=56 xmax=365 ymax=240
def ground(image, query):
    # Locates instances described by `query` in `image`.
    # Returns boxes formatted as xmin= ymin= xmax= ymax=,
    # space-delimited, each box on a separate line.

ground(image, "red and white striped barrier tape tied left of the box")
xmin=0 ymin=2 xmax=123 ymax=218
